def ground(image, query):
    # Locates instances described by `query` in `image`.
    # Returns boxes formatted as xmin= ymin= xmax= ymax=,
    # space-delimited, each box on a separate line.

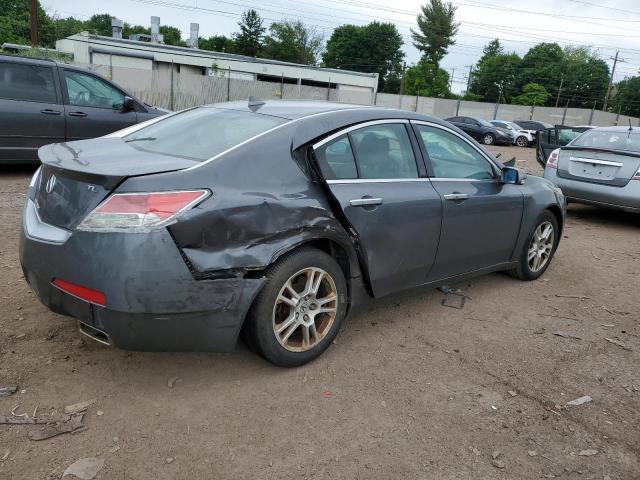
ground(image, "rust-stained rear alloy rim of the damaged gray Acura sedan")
xmin=273 ymin=267 xmax=338 ymax=352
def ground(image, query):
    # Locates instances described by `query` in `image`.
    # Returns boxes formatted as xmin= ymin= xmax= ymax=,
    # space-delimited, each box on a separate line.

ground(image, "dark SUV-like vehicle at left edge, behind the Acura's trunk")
xmin=0 ymin=55 xmax=167 ymax=163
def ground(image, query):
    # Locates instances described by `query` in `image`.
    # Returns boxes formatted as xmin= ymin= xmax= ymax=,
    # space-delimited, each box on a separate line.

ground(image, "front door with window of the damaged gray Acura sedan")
xmin=415 ymin=122 xmax=523 ymax=281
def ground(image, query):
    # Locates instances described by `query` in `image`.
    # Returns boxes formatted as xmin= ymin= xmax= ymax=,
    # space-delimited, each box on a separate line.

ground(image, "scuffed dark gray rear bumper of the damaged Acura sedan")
xmin=20 ymin=200 xmax=264 ymax=351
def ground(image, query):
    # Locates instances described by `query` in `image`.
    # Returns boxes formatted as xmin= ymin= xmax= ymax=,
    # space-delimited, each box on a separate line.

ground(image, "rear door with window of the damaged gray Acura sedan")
xmin=314 ymin=120 xmax=442 ymax=297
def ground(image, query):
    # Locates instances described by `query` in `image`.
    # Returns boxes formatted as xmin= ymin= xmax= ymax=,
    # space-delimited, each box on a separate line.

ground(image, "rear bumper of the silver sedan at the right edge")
xmin=544 ymin=168 xmax=640 ymax=212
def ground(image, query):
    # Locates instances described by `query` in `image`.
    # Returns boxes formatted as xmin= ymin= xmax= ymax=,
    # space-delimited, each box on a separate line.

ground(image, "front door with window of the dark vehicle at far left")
xmin=62 ymin=68 xmax=138 ymax=141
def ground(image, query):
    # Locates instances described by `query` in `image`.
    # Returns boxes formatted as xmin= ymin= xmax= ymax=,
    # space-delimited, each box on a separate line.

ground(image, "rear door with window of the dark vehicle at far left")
xmin=0 ymin=61 xmax=64 ymax=163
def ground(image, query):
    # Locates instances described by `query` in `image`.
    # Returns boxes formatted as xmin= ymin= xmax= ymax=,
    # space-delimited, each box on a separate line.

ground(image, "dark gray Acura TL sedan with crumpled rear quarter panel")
xmin=20 ymin=101 xmax=565 ymax=366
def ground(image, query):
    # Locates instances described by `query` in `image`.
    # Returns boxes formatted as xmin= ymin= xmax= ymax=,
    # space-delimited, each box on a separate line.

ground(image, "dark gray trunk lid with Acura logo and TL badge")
xmin=32 ymin=138 xmax=199 ymax=230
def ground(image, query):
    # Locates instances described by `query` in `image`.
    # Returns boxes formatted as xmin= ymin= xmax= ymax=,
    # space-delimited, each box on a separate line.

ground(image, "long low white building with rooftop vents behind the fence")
xmin=56 ymin=30 xmax=378 ymax=98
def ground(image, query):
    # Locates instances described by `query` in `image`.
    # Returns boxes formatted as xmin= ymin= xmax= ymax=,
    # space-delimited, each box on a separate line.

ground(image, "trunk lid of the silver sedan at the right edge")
xmin=558 ymin=146 xmax=640 ymax=187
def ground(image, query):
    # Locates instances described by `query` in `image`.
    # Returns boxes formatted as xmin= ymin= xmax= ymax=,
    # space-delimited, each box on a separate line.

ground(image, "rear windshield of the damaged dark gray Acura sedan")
xmin=124 ymin=107 xmax=288 ymax=160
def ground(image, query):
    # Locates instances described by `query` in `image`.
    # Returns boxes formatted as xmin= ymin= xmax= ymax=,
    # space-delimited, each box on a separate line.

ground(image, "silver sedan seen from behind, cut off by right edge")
xmin=544 ymin=126 xmax=640 ymax=212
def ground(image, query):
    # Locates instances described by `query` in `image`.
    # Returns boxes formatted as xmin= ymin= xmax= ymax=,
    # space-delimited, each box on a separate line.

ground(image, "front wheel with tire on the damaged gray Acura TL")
xmin=509 ymin=210 xmax=560 ymax=281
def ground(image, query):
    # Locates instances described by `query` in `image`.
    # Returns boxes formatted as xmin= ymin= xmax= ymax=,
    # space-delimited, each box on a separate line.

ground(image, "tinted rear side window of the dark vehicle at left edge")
xmin=0 ymin=62 xmax=56 ymax=103
